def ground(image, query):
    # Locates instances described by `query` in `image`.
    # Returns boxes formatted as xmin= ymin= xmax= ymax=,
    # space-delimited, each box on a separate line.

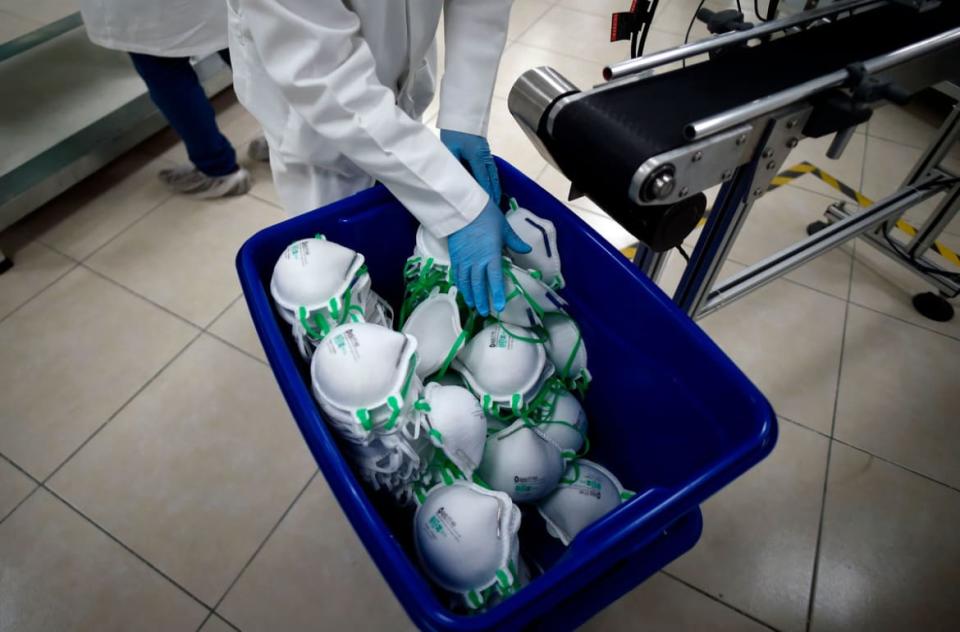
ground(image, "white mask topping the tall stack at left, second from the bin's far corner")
xmin=310 ymin=323 xmax=417 ymax=433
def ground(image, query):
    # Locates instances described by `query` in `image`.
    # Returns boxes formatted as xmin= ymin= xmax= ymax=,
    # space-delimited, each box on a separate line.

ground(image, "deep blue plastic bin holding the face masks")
xmin=237 ymin=160 xmax=777 ymax=630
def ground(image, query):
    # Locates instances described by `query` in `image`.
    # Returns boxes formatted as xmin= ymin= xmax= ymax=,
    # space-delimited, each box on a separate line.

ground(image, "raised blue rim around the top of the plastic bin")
xmin=236 ymin=157 xmax=777 ymax=630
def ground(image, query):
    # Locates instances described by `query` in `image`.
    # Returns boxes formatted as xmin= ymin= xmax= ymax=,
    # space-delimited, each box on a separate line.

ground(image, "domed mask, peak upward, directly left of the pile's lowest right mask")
xmin=477 ymin=419 xmax=564 ymax=502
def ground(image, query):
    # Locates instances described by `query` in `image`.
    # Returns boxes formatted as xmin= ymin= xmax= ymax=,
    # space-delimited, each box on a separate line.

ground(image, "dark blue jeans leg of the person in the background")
xmin=130 ymin=50 xmax=238 ymax=176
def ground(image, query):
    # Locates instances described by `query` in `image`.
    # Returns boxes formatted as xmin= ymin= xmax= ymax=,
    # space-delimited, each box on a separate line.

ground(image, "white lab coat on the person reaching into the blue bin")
xmin=227 ymin=0 xmax=512 ymax=238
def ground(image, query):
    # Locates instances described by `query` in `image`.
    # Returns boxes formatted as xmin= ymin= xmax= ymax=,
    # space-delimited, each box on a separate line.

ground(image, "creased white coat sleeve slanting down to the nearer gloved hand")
xmin=240 ymin=0 xmax=489 ymax=237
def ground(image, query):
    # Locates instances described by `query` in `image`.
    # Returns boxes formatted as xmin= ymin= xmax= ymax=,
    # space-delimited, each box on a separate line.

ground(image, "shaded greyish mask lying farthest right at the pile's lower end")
xmin=538 ymin=459 xmax=634 ymax=545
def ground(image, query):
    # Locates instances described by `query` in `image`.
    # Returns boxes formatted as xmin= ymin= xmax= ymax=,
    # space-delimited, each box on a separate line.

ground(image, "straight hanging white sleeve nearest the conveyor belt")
xmin=437 ymin=0 xmax=513 ymax=136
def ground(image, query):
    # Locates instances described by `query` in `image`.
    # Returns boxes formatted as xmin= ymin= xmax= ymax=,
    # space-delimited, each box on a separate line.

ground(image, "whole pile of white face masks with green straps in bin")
xmin=271 ymin=202 xmax=631 ymax=610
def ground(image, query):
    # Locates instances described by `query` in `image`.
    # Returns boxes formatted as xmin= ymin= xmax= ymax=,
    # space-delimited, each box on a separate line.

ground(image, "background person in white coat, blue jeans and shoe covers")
xmin=80 ymin=0 xmax=265 ymax=198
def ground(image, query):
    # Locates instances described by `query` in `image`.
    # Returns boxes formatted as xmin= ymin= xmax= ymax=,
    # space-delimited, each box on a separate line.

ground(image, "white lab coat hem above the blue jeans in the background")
xmin=80 ymin=0 xmax=227 ymax=57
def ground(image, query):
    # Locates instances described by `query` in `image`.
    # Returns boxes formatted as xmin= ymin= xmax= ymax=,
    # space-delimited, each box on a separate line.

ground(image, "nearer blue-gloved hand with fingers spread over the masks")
xmin=447 ymin=199 xmax=531 ymax=316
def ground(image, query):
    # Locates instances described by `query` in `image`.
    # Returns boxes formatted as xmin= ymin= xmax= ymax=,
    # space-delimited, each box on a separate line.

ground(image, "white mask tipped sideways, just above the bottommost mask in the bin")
xmin=415 ymin=384 xmax=487 ymax=479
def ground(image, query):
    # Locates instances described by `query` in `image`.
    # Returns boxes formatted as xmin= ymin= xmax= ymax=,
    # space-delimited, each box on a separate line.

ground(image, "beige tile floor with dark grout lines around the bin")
xmin=0 ymin=0 xmax=960 ymax=632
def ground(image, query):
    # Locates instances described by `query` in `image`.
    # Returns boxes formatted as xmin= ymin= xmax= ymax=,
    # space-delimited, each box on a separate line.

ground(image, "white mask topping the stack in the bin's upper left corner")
xmin=270 ymin=238 xmax=369 ymax=339
